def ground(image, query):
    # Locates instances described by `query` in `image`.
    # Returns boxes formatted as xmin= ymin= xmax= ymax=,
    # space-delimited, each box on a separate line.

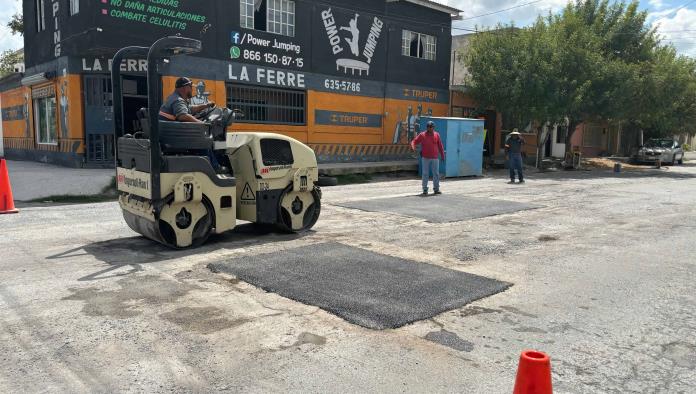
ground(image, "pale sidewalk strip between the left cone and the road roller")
xmin=7 ymin=160 xmax=116 ymax=202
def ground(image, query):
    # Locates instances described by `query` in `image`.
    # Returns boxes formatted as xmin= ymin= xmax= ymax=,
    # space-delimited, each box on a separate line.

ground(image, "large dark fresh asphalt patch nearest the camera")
xmin=208 ymin=242 xmax=511 ymax=330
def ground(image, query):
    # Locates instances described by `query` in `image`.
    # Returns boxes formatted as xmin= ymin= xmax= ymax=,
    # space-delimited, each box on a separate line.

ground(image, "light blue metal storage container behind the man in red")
xmin=418 ymin=116 xmax=485 ymax=177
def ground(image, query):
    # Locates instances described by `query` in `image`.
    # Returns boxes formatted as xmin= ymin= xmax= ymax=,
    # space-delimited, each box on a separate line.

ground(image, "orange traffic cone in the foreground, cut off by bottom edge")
xmin=513 ymin=350 xmax=553 ymax=394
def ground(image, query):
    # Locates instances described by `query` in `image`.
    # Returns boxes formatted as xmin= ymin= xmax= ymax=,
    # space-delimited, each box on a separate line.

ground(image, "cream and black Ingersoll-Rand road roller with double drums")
xmin=112 ymin=36 xmax=321 ymax=248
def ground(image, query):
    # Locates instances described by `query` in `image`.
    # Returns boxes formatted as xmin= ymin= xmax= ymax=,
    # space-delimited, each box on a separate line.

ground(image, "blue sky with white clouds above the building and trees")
xmin=0 ymin=0 xmax=696 ymax=57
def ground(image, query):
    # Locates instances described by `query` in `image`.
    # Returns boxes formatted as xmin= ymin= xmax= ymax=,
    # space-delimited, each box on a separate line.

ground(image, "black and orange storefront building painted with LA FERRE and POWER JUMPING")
xmin=0 ymin=0 xmax=459 ymax=167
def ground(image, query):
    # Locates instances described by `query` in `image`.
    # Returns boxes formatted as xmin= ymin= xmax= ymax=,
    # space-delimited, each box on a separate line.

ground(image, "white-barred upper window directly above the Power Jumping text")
xmin=239 ymin=0 xmax=295 ymax=37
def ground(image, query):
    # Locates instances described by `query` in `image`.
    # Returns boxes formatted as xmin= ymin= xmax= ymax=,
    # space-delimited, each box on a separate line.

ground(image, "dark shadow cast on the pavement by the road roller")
xmin=47 ymin=223 xmax=312 ymax=282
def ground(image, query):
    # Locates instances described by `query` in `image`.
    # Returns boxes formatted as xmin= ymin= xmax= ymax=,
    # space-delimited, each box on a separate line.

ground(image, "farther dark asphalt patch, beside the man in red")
xmin=335 ymin=194 xmax=543 ymax=223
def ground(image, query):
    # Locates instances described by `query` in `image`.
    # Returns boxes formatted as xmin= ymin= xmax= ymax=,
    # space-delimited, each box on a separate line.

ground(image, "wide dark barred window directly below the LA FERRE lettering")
xmin=227 ymin=84 xmax=307 ymax=125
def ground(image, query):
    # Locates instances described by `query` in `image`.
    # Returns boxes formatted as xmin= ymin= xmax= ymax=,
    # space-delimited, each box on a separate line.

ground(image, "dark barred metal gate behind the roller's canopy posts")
xmin=84 ymin=75 xmax=114 ymax=164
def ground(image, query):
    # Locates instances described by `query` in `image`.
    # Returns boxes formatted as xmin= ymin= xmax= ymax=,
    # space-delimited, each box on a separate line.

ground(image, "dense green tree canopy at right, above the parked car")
xmin=465 ymin=0 xmax=696 ymax=149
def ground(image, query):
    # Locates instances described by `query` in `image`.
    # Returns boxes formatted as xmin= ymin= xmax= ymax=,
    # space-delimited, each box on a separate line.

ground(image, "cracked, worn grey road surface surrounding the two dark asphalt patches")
xmin=0 ymin=164 xmax=696 ymax=393
